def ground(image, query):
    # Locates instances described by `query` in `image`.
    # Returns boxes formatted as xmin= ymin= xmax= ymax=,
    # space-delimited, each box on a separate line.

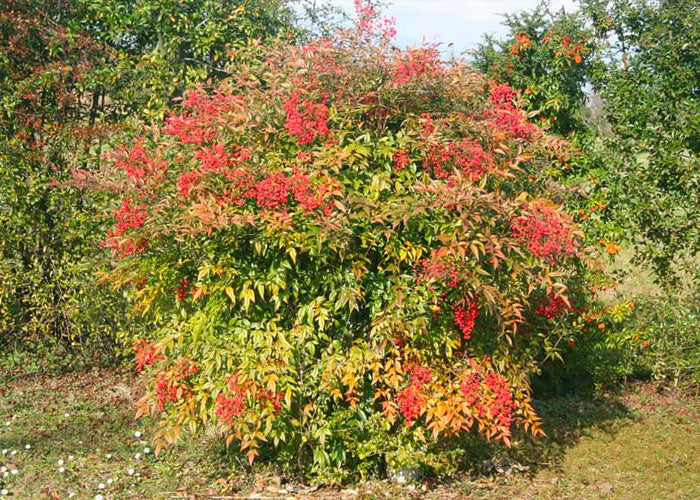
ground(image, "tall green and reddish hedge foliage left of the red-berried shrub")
xmin=0 ymin=0 xmax=296 ymax=354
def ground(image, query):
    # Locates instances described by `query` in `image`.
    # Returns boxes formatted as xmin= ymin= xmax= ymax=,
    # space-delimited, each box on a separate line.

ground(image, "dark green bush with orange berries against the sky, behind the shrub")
xmin=474 ymin=2 xmax=592 ymax=135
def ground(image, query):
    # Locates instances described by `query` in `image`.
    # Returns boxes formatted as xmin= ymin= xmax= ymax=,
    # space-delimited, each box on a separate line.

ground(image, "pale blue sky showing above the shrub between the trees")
xmin=333 ymin=0 xmax=575 ymax=55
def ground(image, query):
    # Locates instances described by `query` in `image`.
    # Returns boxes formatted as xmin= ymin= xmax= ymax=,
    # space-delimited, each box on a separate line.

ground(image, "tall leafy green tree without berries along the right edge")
xmin=582 ymin=0 xmax=700 ymax=281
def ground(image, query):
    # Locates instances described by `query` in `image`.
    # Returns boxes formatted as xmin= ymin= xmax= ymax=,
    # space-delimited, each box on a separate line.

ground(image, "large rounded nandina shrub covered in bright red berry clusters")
xmin=76 ymin=5 xmax=588 ymax=481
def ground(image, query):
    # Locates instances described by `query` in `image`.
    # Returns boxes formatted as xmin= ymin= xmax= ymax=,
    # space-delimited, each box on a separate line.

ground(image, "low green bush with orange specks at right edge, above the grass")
xmin=537 ymin=295 xmax=700 ymax=391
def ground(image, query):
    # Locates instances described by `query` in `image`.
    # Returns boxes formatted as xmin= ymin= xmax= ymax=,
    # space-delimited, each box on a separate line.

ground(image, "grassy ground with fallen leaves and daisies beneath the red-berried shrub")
xmin=0 ymin=364 xmax=700 ymax=500
